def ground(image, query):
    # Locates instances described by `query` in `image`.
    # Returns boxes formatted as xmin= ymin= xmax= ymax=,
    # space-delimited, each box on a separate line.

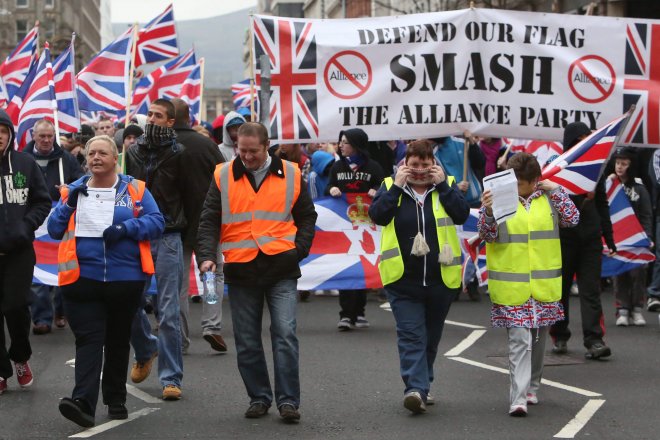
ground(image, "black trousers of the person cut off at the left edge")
xmin=0 ymin=246 xmax=35 ymax=379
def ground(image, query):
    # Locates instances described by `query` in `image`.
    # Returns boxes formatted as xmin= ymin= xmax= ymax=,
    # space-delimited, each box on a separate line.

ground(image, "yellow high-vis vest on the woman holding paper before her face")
xmin=486 ymin=194 xmax=561 ymax=306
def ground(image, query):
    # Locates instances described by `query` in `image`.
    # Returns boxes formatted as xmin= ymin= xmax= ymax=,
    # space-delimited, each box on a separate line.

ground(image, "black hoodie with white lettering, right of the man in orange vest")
xmin=325 ymin=128 xmax=385 ymax=195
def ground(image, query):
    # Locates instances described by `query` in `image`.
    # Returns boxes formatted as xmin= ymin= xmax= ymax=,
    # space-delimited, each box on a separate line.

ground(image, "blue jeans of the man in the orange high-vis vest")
xmin=229 ymin=280 xmax=300 ymax=408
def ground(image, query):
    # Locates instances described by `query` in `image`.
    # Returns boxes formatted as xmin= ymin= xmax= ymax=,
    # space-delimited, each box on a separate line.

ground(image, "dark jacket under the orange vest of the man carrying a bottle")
xmin=197 ymin=156 xmax=317 ymax=286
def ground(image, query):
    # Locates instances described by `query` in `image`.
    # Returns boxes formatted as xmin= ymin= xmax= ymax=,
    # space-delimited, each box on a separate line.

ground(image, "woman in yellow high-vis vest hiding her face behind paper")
xmin=478 ymin=153 xmax=580 ymax=417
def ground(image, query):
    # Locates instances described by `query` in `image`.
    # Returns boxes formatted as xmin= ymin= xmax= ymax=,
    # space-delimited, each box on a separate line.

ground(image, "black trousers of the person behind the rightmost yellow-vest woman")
xmin=550 ymin=241 xmax=605 ymax=348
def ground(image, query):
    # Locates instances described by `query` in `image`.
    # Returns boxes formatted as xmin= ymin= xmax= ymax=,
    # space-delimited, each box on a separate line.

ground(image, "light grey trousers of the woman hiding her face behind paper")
xmin=507 ymin=327 xmax=548 ymax=406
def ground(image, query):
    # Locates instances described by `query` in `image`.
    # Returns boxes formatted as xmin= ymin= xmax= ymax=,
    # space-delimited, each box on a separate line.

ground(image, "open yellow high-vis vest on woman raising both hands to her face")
xmin=378 ymin=176 xmax=461 ymax=289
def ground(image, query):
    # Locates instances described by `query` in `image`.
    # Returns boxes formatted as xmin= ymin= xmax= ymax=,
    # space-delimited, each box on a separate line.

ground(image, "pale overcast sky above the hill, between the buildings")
xmin=110 ymin=0 xmax=257 ymax=23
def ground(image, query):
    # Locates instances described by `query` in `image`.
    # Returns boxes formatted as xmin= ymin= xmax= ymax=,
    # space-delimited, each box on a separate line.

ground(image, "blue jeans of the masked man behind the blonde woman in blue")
xmin=131 ymin=233 xmax=183 ymax=387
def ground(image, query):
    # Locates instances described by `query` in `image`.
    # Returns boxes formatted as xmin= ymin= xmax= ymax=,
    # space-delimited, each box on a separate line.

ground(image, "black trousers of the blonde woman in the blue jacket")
xmin=62 ymin=278 xmax=144 ymax=414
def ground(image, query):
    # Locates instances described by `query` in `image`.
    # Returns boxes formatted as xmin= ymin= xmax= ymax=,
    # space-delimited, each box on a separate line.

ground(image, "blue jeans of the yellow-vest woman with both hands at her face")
xmin=385 ymin=280 xmax=456 ymax=400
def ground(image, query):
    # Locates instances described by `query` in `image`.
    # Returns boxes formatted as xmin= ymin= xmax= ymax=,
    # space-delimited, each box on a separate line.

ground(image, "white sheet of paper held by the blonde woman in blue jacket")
xmin=76 ymin=188 xmax=117 ymax=237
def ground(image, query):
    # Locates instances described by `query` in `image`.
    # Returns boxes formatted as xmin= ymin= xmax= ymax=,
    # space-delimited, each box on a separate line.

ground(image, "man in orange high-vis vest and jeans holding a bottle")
xmin=197 ymin=122 xmax=316 ymax=423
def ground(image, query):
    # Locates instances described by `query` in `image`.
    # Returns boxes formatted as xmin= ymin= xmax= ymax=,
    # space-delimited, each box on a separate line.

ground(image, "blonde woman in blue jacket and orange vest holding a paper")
xmin=48 ymin=136 xmax=165 ymax=427
